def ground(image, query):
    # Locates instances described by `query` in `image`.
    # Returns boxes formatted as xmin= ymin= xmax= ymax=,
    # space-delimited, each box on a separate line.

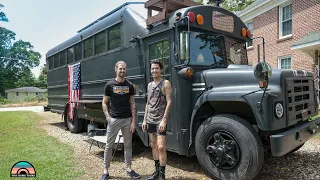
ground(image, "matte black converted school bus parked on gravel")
xmin=47 ymin=3 xmax=320 ymax=180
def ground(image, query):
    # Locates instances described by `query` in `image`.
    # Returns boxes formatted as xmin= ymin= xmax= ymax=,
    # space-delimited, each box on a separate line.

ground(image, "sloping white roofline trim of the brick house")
xmin=237 ymin=0 xmax=292 ymax=22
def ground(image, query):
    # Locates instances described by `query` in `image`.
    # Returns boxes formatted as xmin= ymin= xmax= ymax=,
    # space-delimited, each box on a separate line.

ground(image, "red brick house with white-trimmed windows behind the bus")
xmin=237 ymin=0 xmax=320 ymax=94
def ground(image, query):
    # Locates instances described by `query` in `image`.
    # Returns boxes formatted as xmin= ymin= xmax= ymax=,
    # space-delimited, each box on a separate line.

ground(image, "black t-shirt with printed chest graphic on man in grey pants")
xmin=104 ymin=79 xmax=134 ymax=118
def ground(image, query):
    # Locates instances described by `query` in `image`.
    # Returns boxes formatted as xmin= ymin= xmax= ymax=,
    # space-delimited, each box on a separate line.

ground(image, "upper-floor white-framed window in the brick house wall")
xmin=279 ymin=4 xmax=292 ymax=38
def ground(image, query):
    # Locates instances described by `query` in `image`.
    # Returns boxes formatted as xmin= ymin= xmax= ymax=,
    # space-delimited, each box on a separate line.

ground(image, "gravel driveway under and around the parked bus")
xmin=39 ymin=112 xmax=320 ymax=180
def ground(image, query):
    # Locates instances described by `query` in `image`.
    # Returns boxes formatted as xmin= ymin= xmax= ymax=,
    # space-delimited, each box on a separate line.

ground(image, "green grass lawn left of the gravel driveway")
xmin=0 ymin=112 xmax=81 ymax=180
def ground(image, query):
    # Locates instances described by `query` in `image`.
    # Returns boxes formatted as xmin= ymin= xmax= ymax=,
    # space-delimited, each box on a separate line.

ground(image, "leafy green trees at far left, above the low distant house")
xmin=0 ymin=27 xmax=41 ymax=96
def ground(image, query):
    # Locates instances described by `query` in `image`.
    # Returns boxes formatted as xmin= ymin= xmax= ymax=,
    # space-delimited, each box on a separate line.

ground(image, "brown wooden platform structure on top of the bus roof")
xmin=145 ymin=0 xmax=200 ymax=26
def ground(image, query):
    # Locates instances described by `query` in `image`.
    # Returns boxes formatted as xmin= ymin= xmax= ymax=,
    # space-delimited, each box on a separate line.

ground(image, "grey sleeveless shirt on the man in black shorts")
xmin=147 ymin=80 xmax=167 ymax=124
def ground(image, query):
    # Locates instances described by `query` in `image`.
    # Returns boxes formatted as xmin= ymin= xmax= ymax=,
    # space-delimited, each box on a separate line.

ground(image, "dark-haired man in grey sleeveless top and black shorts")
xmin=142 ymin=61 xmax=172 ymax=180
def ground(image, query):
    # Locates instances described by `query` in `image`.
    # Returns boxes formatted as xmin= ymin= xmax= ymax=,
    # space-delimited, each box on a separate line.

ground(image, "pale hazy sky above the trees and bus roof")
xmin=0 ymin=0 xmax=145 ymax=77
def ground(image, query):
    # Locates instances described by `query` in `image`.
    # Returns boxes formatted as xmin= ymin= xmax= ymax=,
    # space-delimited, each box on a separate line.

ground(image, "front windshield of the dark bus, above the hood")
xmin=180 ymin=32 xmax=248 ymax=67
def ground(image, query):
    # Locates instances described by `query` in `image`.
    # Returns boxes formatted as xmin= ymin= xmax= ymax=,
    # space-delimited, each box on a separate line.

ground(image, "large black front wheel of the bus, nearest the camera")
xmin=195 ymin=114 xmax=264 ymax=180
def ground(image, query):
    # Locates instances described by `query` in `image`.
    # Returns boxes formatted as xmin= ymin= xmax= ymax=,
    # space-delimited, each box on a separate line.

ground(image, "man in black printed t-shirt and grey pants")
xmin=100 ymin=61 xmax=141 ymax=180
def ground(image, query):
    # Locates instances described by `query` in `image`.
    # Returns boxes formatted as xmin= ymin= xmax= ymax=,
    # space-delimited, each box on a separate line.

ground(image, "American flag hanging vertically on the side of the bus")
xmin=68 ymin=63 xmax=80 ymax=119
